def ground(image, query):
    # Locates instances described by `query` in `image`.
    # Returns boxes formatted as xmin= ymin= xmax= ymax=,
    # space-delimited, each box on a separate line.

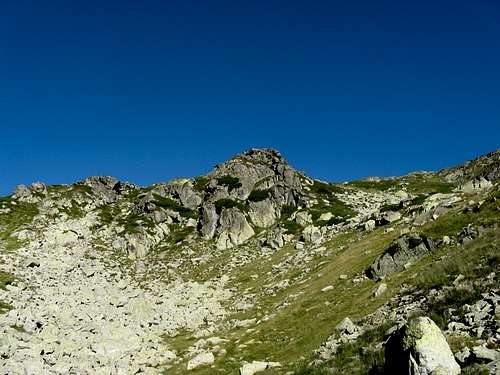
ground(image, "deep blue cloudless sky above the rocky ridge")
xmin=0 ymin=0 xmax=500 ymax=195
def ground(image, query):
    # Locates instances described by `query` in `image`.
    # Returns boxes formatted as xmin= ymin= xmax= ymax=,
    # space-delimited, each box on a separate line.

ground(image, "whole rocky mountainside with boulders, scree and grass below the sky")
xmin=0 ymin=149 xmax=500 ymax=375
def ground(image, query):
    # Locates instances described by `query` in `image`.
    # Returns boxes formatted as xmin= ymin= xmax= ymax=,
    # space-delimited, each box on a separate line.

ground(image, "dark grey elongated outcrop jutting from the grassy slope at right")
xmin=368 ymin=234 xmax=436 ymax=279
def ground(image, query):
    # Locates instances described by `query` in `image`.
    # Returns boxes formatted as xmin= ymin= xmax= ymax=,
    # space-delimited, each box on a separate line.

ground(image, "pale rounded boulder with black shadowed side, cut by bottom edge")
xmin=385 ymin=317 xmax=460 ymax=375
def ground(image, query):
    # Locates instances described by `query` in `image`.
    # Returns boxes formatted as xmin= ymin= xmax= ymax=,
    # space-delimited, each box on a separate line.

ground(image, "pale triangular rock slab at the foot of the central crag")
xmin=216 ymin=208 xmax=255 ymax=249
